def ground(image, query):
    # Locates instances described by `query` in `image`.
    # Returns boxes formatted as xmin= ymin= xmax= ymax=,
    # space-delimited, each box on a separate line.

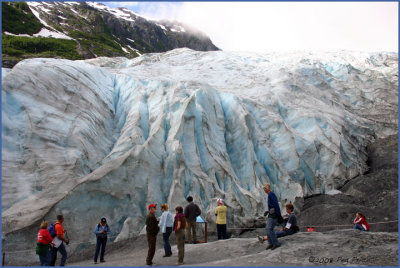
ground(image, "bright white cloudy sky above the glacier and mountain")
xmin=104 ymin=2 xmax=398 ymax=52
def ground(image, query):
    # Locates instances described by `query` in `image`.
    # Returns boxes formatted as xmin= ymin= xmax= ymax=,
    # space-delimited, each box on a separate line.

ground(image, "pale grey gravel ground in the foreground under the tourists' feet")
xmin=68 ymin=229 xmax=398 ymax=266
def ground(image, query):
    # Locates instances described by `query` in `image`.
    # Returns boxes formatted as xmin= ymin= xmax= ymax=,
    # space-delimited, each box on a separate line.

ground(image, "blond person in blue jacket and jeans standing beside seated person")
xmin=263 ymin=183 xmax=282 ymax=250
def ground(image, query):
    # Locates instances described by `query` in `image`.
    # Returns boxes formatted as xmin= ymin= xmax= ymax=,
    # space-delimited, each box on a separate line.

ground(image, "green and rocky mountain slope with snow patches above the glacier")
xmin=2 ymin=2 xmax=218 ymax=67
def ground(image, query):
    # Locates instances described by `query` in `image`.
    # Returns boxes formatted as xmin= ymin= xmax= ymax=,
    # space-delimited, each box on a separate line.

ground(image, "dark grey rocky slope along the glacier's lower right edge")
xmin=298 ymin=136 xmax=399 ymax=232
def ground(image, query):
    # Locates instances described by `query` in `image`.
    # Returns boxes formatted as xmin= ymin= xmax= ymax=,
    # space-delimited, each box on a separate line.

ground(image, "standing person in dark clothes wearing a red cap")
xmin=146 ymin=204 xmax=160 ymax=265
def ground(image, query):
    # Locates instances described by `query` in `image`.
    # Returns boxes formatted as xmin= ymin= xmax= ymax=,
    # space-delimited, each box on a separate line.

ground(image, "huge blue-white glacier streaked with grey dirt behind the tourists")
xmin=2 ymin=49 xmax=398 ymax=259
